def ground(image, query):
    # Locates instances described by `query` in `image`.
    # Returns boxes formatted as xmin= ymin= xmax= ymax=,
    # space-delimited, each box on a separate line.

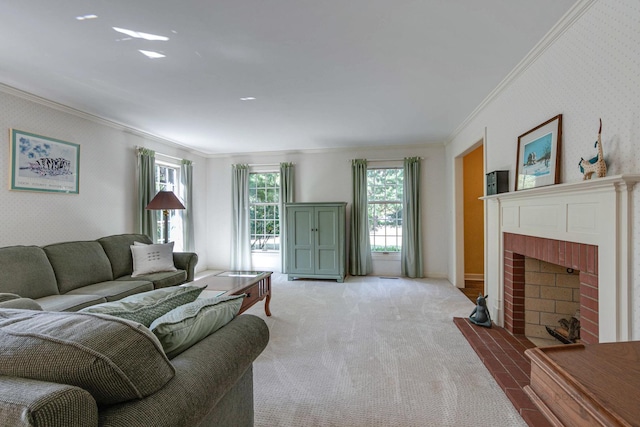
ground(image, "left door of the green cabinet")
xmin=287 ymin=207 xmax=315 ymax=274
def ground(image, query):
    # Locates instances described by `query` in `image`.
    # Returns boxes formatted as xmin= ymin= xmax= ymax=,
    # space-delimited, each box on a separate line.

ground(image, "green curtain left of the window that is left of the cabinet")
xmin=231 ymin=164 xmax=251 ymax=271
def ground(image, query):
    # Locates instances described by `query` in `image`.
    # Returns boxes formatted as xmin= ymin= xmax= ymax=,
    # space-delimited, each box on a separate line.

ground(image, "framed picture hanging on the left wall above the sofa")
xmin=9 ymin=129 xmax=80 ymax=194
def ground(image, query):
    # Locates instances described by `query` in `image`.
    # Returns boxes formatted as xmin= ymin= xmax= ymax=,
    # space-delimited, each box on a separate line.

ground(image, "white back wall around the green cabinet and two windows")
xmin=207 ymin=144 xmax=447 ymax=277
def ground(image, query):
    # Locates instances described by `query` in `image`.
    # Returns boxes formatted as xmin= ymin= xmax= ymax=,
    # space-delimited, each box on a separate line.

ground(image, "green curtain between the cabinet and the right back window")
xmin=349 ymin=159 xmax=373 ymax=276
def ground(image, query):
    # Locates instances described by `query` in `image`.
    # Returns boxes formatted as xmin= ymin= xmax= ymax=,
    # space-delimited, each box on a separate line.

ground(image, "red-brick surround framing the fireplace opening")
xmin=503 ymin=233 xmax=598 ymax=344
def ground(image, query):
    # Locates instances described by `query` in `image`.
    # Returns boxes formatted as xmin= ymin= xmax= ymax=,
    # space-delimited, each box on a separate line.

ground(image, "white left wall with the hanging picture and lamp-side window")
xmin=0 ymin=88 xmax=206 ymax=269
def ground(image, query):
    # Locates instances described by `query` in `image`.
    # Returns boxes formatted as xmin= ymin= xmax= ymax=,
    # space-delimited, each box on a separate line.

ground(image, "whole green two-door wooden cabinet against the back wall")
xmin=285 ymin=202 xmax=347 ymax=282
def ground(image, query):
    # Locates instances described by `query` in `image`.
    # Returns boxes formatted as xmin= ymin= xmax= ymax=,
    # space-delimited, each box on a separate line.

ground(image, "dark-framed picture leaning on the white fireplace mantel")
xmin=516 ymin=114 xmax=562 ymax=191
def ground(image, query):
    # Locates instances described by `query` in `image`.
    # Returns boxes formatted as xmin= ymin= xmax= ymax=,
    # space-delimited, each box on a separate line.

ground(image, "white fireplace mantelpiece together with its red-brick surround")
xmin=484 ymin=175 xmax=640 ymax=343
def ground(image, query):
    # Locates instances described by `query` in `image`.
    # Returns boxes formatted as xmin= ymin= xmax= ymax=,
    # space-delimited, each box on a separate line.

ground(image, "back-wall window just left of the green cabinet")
xmin=249 ymin=172 xmax=280 ymax=251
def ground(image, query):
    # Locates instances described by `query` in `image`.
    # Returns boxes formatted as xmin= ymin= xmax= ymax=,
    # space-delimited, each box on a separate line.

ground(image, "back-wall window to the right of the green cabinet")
xmin=367 ymin=168 xmax=404 ymax=252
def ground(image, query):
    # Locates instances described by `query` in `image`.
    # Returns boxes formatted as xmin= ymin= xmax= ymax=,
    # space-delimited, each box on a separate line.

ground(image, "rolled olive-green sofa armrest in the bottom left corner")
xmin=0 ymin=376 xmax=98 ymax=427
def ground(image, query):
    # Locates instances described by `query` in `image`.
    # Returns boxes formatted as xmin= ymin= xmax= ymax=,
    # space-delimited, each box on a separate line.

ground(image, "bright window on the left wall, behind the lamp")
xmin=156 ymin=161 xmax=182 ymax=251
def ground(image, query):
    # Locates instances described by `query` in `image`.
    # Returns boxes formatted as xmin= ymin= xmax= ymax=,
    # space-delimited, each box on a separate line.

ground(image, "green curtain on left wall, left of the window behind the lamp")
xmin=138 ymin=148 xmax=159 ymax=242
